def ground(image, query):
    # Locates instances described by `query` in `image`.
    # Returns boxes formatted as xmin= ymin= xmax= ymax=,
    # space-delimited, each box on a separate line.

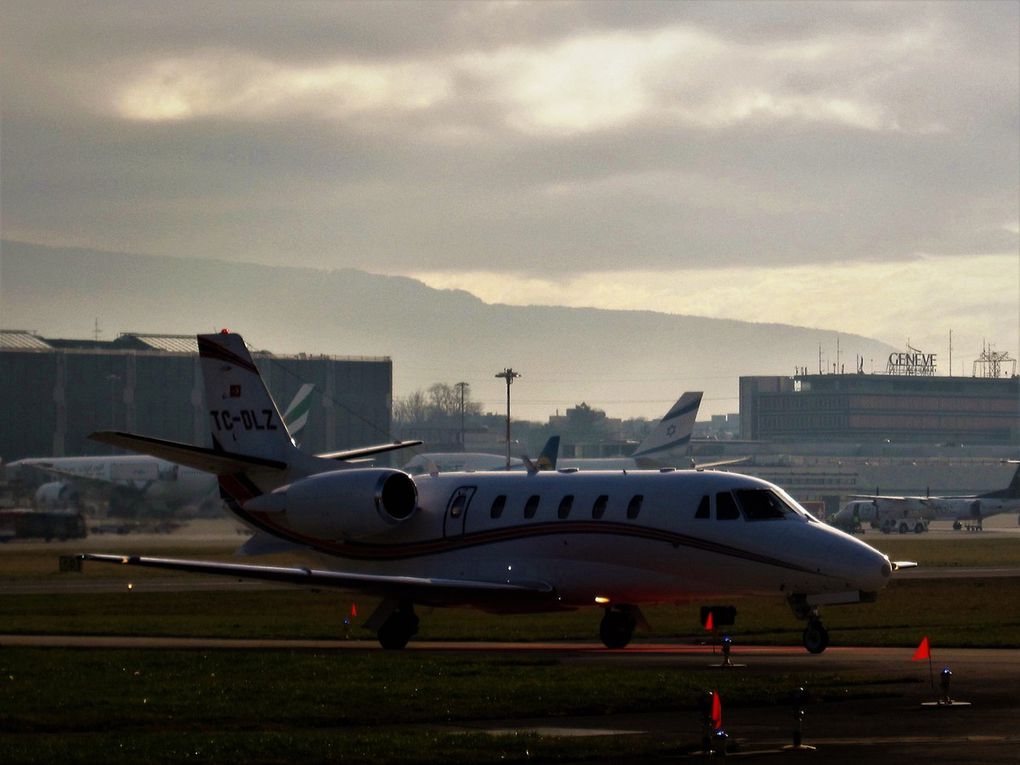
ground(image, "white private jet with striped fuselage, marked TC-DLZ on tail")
xmin=81 ymin=330 xmax=903 ymax=653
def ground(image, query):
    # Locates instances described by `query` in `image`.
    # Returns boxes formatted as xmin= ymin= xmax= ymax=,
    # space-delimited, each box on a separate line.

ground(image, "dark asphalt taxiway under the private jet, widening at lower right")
xmin=0 ymin=635 xmax=1020 ymax=765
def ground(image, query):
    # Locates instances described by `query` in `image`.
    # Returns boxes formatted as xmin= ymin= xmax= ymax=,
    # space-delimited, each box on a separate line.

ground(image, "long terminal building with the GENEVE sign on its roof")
xmin=722 ymin=349 xmax=1020 ymax=513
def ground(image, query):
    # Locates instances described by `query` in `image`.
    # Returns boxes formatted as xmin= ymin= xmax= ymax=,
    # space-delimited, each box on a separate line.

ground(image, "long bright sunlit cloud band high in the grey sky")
xmin=97 ymin=17 xmax=946 ymax=138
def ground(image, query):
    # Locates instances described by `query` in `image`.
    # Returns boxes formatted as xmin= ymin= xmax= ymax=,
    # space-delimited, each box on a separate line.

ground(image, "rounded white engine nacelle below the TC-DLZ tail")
xmin=244 ymin=467 xmax=418 ymax=540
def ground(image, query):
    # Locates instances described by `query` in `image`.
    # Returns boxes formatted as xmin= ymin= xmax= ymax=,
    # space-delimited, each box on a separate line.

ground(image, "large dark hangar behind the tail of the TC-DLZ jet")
xmin=0 ymin=329 xmax=393 ymax=462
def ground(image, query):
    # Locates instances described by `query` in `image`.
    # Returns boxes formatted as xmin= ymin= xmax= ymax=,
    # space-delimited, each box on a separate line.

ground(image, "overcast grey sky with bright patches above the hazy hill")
xmin=0 ymin=0 xmax=1020 ymax=371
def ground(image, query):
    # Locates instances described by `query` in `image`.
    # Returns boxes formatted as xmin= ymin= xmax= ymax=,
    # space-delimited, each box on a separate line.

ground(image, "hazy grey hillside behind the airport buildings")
xmin=0 ymin=241 xmax=898 ymax=421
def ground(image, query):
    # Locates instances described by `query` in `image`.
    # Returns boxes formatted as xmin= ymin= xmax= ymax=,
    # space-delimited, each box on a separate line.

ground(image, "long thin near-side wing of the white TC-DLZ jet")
xmin=78 ymin=553 xmax=554 ymax=605
